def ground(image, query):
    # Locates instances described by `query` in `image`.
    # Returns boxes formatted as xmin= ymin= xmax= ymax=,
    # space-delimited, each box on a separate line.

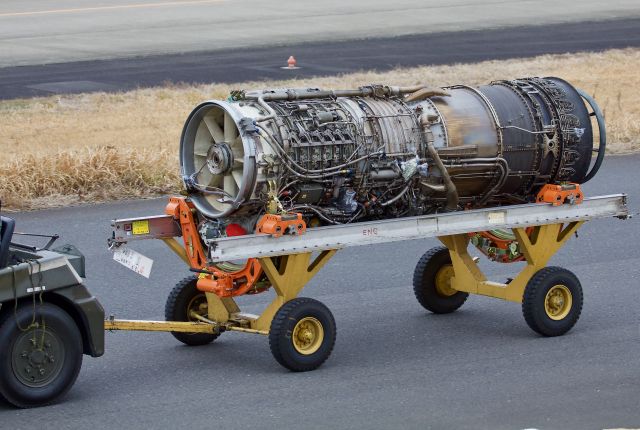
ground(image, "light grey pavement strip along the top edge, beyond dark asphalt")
xmin=0 ymin=0 xmax=640 ymax=67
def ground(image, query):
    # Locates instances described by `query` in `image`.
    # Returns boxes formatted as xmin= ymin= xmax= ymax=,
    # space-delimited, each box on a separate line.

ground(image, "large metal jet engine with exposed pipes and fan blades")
xmin=180 ymin=77 xmax=605 ymax=237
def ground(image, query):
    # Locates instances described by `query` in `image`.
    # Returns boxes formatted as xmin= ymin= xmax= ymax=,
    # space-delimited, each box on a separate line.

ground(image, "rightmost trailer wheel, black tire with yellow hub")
xmin=522 ymin=267 xmax=582 ymax=336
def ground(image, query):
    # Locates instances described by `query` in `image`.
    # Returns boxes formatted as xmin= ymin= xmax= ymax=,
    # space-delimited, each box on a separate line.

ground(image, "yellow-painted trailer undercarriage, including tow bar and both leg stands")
xmin=110 ymin=221 xmax=583 ymax=335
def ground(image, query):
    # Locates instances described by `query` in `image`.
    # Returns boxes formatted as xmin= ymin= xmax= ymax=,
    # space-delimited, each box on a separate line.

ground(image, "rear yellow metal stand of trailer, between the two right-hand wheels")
xmin=438 ymin=221 xmax=583 ymax=303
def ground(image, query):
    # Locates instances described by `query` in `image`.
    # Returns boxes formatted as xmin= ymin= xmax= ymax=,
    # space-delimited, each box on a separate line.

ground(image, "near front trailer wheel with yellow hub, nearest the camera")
xmin=269 ymin=297 xmax=336 ymax=372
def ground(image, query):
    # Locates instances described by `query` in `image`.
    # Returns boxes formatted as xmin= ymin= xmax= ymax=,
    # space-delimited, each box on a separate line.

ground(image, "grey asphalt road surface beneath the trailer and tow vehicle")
xmin=0 ymin=155 xmax=640 ymax=430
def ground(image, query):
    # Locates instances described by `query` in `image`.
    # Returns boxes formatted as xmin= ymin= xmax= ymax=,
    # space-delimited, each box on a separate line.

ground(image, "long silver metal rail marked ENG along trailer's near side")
xmin=209 ymin=194 xmax=629 ymax=262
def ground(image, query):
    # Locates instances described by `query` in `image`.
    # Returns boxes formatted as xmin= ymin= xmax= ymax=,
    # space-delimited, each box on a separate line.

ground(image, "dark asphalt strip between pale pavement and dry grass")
xmin=0 ymin=16 xmax=640 ymax=99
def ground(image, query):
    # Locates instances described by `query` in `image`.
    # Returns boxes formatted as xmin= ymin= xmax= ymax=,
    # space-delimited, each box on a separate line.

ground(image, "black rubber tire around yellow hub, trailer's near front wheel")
xmin=269 ymin=297 xmax=336 ymax=372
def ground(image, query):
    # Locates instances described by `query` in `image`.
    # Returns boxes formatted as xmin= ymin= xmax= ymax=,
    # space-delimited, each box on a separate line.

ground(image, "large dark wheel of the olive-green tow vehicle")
xmin=0 ymin=303 xmax=82 ymax=408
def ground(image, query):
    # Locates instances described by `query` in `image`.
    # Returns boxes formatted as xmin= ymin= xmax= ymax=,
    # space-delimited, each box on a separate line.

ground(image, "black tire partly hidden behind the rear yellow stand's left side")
xmin=413 ymin=246 xmax=469 ymax=314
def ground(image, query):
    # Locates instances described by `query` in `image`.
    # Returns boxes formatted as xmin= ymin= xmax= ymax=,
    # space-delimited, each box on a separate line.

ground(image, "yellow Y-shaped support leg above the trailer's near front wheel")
xmin=251 ymin=250 xmax=336 ymax=332
